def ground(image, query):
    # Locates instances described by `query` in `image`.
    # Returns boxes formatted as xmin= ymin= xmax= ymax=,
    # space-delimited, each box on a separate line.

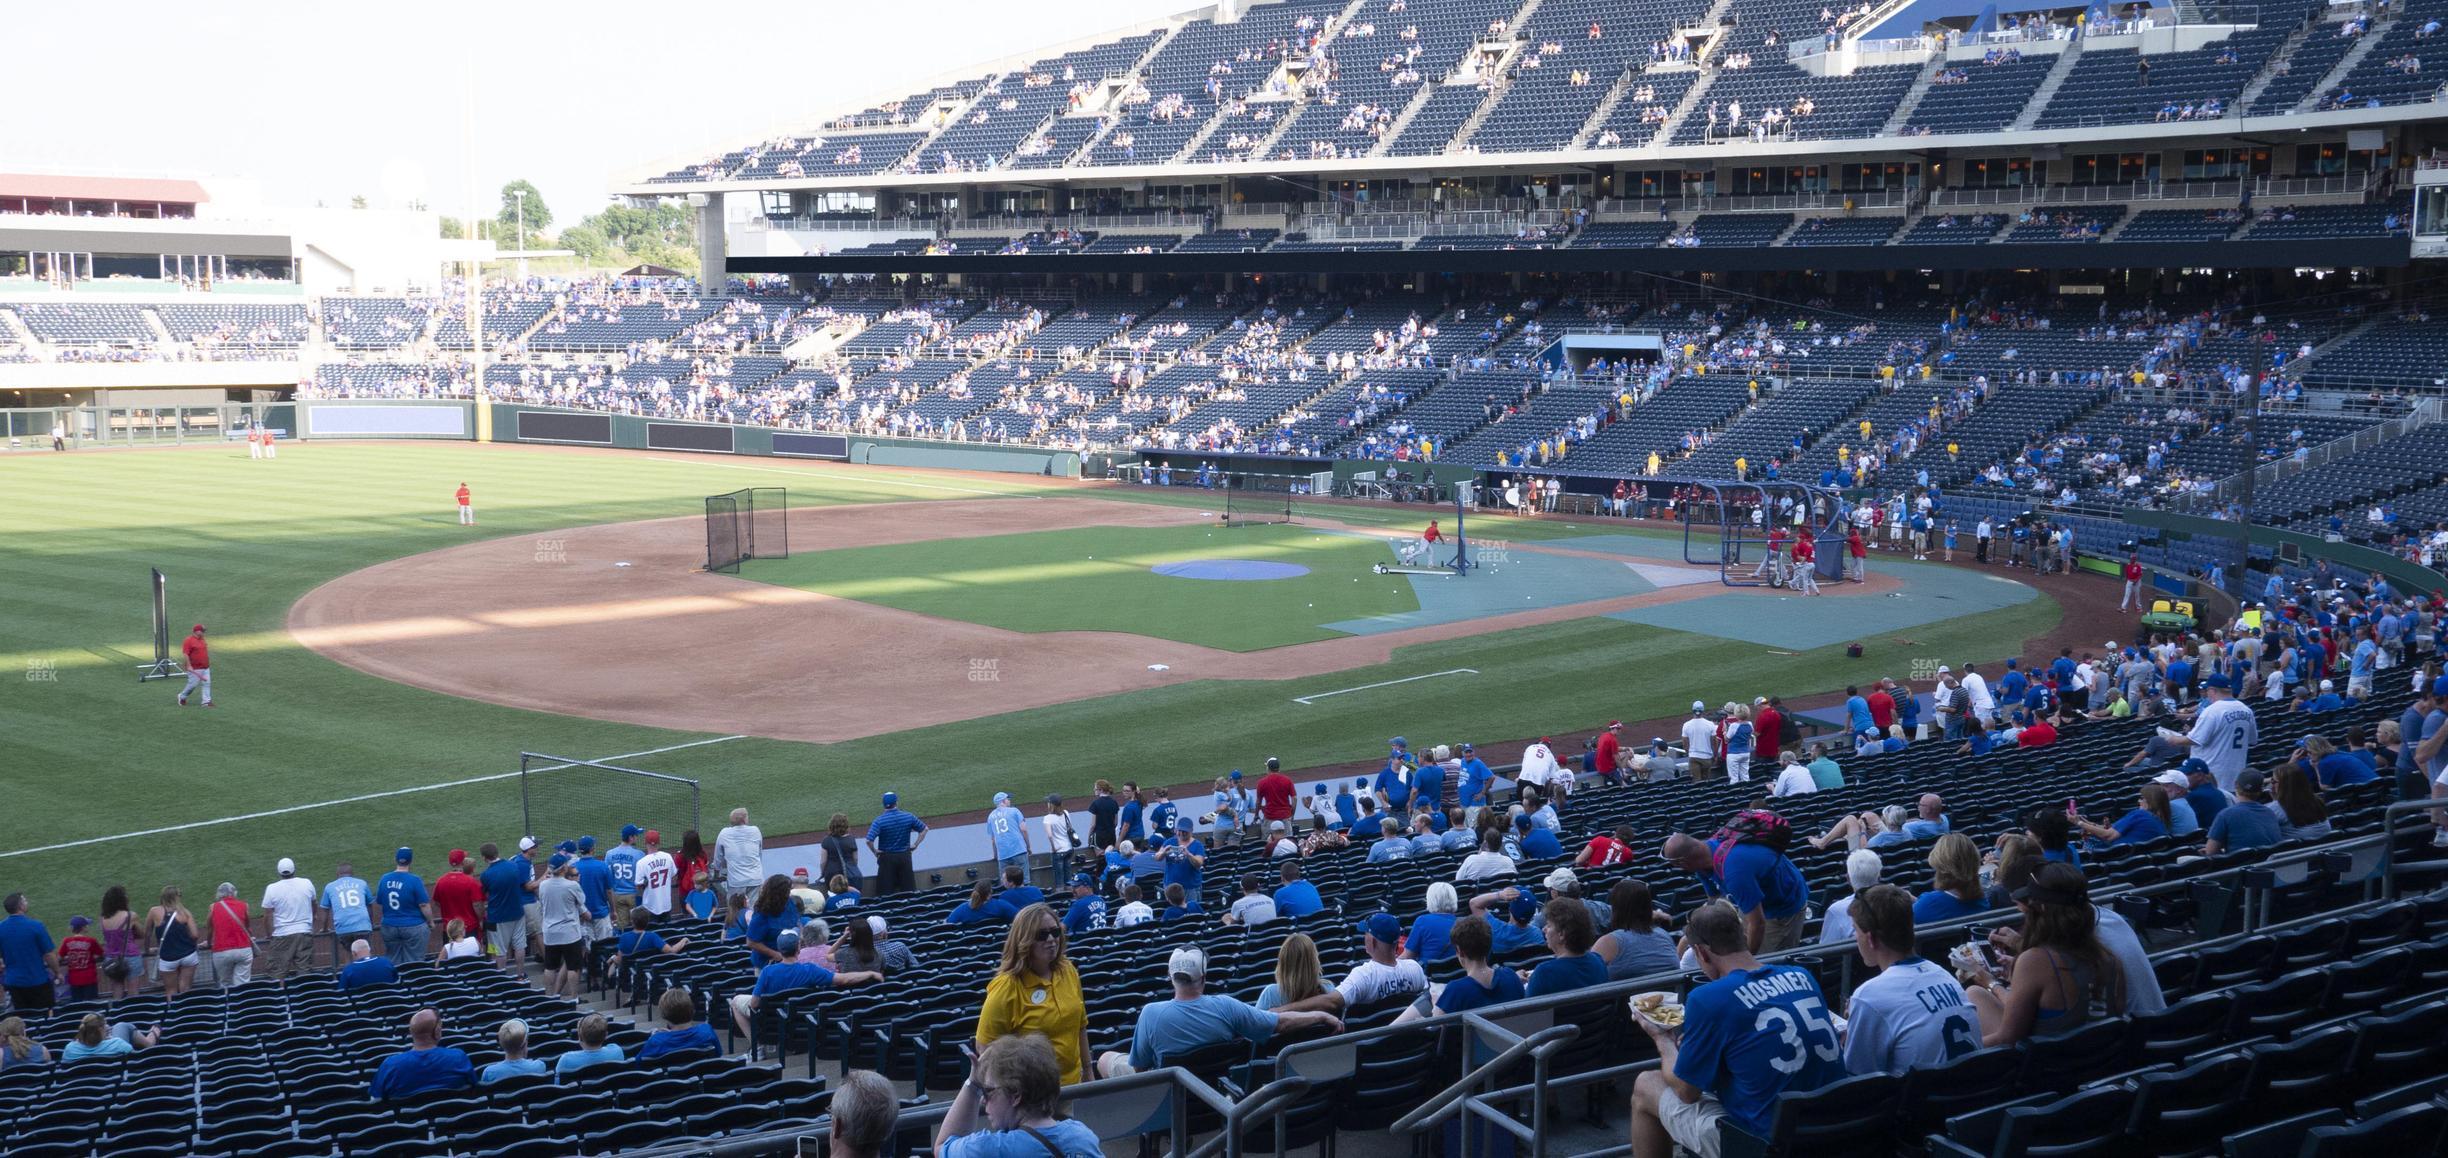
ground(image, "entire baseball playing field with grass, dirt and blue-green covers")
xmin=0 ymin=443 xmax=2061 ymax=918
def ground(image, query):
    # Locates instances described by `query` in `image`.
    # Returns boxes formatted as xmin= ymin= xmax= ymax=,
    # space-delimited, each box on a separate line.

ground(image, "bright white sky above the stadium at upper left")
xmin=0 ymin=0 xmax=1200 ymax=223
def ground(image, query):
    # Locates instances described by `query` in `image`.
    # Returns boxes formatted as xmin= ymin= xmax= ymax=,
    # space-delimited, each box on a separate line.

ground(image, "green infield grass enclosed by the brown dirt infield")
xmin=739 ymin=524 xmax=1420 ymax=651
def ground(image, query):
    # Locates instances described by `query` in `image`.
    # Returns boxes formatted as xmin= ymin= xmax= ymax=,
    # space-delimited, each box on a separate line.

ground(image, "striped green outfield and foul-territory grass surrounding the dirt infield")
xmin=0 ymin=443 xmax=2056 ymax=910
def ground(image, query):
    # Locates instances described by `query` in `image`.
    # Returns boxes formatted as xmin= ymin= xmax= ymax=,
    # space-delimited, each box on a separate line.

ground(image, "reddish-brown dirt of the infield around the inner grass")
xmin=289 ymin=497 xmax=1897 ymax=744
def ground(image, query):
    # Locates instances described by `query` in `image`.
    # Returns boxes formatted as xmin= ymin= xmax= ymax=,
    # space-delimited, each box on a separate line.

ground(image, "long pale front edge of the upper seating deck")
xmin=612 ymin=103 xmax=2448 ymax=196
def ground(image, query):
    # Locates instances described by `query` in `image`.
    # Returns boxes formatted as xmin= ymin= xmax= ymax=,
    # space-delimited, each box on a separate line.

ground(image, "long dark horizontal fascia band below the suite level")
xmin=730 ymin=237 xmax=2414 ymax=277
